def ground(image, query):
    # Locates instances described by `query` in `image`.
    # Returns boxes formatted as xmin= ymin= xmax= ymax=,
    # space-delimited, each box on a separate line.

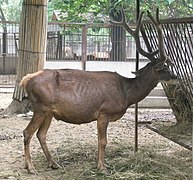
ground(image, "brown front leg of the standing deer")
xmin=97 ymin=119 xmax=109 ymax=171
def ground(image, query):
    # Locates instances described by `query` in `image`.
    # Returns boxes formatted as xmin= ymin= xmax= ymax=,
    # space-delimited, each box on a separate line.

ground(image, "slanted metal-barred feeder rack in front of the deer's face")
xmin=143 ymin=18 xmax=193 ymax=121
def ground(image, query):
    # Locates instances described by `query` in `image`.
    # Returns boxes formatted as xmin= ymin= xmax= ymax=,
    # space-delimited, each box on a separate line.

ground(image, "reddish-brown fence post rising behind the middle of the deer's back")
xmin=82 ymin=25 xmax=88 ymax=70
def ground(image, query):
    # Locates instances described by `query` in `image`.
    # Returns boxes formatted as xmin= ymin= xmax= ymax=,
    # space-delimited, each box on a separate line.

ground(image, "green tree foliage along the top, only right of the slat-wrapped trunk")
xmin=50 ymin=0 xmax=193 ymax=22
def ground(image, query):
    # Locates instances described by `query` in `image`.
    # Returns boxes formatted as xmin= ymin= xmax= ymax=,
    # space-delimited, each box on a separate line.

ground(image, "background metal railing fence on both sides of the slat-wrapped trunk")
xmin=0 ymin=21 xmax=146 ymax=86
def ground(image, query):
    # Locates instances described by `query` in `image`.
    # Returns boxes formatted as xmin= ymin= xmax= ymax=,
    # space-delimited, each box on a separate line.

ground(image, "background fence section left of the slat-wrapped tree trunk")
xmin=0 ymin=22 xmax=19 ymax=86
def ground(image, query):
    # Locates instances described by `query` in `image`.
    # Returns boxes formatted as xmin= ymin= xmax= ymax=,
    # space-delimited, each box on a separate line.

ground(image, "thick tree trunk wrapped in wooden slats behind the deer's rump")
xmin=4 ymin=0 xmax=47 ymax=113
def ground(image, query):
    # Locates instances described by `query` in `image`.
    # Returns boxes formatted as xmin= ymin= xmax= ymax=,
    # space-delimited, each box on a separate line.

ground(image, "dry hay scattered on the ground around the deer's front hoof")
xmin=35 ymin=143 xmax=192 ymax=180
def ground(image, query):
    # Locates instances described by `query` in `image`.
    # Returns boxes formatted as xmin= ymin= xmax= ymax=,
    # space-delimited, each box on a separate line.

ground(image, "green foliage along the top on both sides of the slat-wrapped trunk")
xmin=0 ymin=0 xmax=193 ymax=23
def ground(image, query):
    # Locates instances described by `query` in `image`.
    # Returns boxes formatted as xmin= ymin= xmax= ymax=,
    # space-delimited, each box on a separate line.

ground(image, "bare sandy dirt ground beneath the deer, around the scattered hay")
xmin=0 ymin=93 xmax=192 ymax=180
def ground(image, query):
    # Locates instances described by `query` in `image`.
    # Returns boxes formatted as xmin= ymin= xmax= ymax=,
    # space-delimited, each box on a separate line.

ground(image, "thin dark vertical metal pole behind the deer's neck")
xmin=135 ymin=0 xmax=140 ymax=152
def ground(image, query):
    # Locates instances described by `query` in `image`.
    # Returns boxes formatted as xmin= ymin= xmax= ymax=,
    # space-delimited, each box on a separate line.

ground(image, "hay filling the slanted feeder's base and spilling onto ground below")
xmin=147 ymin=82 xmax=193 ymax=152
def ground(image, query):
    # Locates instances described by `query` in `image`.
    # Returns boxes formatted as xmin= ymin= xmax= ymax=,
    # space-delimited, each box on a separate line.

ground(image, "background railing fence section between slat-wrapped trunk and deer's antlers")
xmin=47 ymin=22 xmax=146 ymax=61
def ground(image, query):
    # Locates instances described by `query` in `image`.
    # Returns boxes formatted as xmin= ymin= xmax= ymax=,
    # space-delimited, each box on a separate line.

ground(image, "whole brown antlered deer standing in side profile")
xmin=20 ymin=9 xmax=177 ymax=173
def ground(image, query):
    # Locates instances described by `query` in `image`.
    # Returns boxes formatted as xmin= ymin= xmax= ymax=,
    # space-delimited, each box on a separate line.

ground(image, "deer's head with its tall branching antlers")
xmin=111 ymin=9 xmax=177 ymax=84
